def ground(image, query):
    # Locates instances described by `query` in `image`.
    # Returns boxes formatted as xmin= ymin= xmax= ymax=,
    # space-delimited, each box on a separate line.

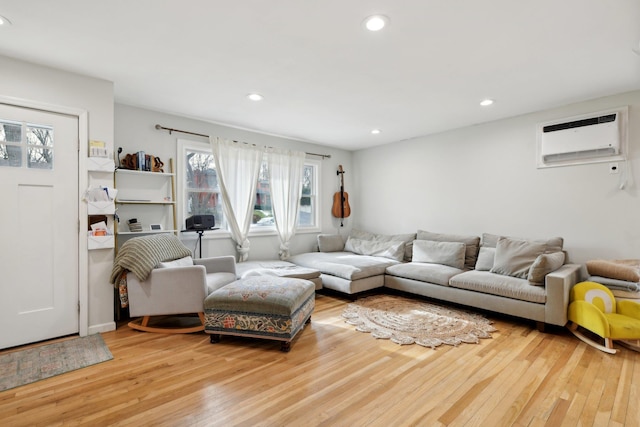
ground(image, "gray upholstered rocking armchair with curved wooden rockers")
xmin=127 ymin=256 xmax=236 ymax=333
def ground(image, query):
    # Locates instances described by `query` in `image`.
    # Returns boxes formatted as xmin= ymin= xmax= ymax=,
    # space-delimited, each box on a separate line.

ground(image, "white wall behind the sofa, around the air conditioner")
xmin=350 ymin=91 xmax=640 ymax=263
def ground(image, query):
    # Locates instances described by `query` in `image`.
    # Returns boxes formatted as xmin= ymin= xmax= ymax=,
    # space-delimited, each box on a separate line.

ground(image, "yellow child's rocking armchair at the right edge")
xmin=568 ymin=282 xmax=640 ymax=354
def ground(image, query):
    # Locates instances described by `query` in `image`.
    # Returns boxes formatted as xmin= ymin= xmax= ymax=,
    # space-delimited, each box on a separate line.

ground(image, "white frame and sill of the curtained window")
xmin=176 ymin=138 xmax=322 ymax=238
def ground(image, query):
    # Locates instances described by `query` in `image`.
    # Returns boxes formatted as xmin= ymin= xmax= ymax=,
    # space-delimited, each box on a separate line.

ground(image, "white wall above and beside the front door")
xmin=0 ymin=56 xmax=115 ymax=333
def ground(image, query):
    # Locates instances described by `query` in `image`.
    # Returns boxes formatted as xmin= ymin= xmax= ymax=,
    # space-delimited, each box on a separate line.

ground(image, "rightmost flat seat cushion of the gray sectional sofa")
xmin=449 ymin=271 xmax=547 ymax=304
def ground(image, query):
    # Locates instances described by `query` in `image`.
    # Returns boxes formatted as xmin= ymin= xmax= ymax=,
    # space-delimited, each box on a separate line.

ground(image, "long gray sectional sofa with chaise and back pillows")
xmin=289 ymin=230 xmax=580 ymax=329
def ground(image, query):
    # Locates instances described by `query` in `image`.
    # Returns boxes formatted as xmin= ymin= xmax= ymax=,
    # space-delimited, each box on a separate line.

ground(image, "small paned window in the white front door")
xmin=0 ymin=119 xmax=53 ymax=169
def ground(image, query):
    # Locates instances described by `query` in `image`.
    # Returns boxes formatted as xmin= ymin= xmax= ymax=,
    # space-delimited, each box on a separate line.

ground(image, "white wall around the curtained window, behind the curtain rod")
xmin=115 ymin=104 xmax=352 ymax=260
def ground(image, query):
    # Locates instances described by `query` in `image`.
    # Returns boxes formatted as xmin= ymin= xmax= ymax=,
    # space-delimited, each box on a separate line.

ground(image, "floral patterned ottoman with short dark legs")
xmin=204 ymin=276 xmax=315 ymax=352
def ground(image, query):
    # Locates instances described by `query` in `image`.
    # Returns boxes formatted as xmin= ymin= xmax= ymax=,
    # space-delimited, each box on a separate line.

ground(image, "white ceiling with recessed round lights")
xmin=0 ymin=0 xmax=640 ymax=150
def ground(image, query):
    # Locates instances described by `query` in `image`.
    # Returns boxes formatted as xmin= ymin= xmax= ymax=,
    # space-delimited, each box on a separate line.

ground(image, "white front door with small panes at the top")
xmin=0 ymin=104 xmax=79 ymax=349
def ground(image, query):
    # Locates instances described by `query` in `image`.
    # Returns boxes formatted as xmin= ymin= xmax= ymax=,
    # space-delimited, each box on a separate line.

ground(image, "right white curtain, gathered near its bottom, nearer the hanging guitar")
xmin=267 ymin=148 xmax=305 ymax=260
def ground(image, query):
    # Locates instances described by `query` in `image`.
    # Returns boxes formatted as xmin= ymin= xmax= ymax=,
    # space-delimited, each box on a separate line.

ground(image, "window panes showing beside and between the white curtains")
xmin=177 ymin=140 xmax=320 ymax=231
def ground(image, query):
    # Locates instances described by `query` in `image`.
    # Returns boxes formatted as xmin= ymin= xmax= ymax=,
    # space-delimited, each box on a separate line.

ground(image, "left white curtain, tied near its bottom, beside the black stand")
xmin=210 ymin=137 xmax=264 ymax=262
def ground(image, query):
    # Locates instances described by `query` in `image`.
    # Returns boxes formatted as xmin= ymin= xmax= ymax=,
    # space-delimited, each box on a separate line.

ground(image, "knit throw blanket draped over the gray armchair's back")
xmin=111 ymin=234 xmax=191 ymax=285
